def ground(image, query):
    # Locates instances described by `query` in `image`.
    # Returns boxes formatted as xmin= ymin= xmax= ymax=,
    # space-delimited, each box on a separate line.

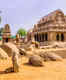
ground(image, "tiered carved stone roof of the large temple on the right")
xmin=33 ymin=9 xmax=66 ymax=32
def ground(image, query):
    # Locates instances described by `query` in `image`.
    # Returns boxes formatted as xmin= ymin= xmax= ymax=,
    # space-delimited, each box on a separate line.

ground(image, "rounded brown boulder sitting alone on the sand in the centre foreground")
xmin=29 ymin=55 xmax=43 ymax=66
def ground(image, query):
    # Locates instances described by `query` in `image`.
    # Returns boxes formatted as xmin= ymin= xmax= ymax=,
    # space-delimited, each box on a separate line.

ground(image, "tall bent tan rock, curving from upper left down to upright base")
xmin=2 ymin=42 xmax=21 ymax=72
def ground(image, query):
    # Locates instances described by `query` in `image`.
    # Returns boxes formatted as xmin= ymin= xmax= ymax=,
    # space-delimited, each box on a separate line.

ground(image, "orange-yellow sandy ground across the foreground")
xmin=0 ymin=57 xmax=66 ymax=80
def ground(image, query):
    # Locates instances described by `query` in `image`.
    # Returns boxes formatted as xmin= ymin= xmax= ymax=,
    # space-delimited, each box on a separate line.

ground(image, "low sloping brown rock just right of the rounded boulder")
xmin=39 ymin=52 xmax=62 ymax=61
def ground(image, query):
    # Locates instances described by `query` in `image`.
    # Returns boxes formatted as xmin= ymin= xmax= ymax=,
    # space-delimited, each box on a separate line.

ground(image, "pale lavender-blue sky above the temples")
xmin=0 ymin=0 xmax=66 ymax=34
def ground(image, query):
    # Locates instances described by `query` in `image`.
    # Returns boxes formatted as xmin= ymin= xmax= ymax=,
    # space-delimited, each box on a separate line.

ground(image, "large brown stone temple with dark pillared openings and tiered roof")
xmin=28 ymin=10 xmax=66 ymax=45
